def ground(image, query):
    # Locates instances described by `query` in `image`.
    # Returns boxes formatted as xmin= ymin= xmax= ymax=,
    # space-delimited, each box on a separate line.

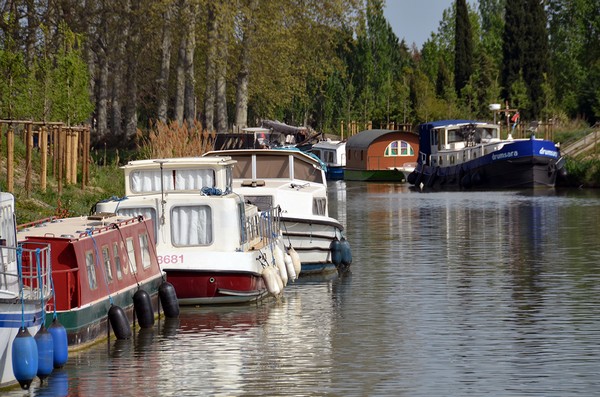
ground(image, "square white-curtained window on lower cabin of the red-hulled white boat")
xmin=171 ymin=205 xmax=213 ymax=246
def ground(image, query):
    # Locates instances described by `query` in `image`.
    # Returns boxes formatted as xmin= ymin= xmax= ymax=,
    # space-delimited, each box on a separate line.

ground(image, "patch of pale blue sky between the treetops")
xmin=383 ymin=0 xmax=454 ymax=49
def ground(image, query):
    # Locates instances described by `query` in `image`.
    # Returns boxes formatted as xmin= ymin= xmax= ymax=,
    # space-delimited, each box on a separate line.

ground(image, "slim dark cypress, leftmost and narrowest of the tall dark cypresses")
xmin=454 ymin=0 xmax=473 ymax=97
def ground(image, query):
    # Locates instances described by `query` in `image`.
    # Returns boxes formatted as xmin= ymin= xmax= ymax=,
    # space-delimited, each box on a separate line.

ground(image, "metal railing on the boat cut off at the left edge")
xmin=0 ymin=241 xmax=52 ymax=300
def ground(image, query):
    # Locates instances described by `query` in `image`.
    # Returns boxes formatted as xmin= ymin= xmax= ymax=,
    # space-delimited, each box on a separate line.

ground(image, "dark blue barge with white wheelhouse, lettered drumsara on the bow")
xmin=408 ymin=120 xmax=565 ymax=189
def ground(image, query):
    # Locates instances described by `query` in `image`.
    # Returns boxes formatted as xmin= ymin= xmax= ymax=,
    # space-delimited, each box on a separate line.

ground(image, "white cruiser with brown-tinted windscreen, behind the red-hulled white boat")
xmin=204 ymin=149 xmax=352 ymax=274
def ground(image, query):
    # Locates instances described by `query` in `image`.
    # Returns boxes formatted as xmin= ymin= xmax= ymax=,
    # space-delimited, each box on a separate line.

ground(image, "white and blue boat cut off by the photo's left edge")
xmin=0 ymin=192 xmax=52 ymax=389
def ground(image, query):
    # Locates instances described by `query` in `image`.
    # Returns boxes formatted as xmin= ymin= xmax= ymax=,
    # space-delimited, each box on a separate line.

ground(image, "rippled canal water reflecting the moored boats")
xmin=7 ymin=182 xmax=600 ymax=397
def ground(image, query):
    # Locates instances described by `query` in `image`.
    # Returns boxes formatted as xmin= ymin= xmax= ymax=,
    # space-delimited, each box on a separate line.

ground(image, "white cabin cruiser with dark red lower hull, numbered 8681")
xmin=96 ymin=157 xmax=290 ymax=305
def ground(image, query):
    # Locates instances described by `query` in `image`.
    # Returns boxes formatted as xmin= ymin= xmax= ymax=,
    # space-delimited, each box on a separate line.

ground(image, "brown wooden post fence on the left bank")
xmin=0 ymin=120 xmax=90 ymax=197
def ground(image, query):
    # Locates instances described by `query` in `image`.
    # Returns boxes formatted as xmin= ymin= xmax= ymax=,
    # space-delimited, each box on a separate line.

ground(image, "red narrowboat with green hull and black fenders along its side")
xmin=18 ymin=214 xmax=169 ymax=350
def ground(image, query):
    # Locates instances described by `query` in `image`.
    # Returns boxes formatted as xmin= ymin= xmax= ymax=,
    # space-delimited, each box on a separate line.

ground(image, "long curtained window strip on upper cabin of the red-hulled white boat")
xmin=129 ymin=169 xmax=215 ymax=193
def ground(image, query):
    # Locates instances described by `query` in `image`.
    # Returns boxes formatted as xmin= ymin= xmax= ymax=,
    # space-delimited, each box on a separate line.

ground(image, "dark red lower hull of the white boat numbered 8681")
xmin=166 ymin=270 xmax=267 ymax=304
